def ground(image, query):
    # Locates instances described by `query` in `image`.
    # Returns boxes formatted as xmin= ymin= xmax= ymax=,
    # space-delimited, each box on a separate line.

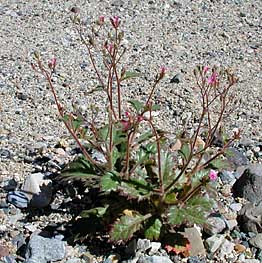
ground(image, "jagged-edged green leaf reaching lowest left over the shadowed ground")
xmin=110 ymin=212 xmax=148 ymax=242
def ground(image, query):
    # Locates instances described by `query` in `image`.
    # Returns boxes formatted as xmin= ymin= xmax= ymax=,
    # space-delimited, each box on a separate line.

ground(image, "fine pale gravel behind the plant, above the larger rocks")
xmin=0 ymin=0 xmax=262 ymax=262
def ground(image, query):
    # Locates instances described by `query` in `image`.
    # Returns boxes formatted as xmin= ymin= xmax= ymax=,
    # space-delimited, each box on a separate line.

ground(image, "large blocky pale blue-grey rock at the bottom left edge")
xmin=25 ymin=235 xmax=66 ymax=263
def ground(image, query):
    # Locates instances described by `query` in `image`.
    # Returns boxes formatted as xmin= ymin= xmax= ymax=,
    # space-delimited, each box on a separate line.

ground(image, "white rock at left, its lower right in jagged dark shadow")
xmin=22 ymin=173 xmax=52 ymax=208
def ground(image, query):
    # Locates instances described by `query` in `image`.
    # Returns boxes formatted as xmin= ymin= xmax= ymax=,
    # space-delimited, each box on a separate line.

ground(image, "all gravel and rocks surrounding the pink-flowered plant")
xmin=0 ymin=0 xmax=262 ymax=263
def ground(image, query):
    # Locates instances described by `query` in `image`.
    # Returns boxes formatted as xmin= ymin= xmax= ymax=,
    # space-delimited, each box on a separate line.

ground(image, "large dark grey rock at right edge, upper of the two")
xmin=232 ymin=164 xmax=262 ymax=204
